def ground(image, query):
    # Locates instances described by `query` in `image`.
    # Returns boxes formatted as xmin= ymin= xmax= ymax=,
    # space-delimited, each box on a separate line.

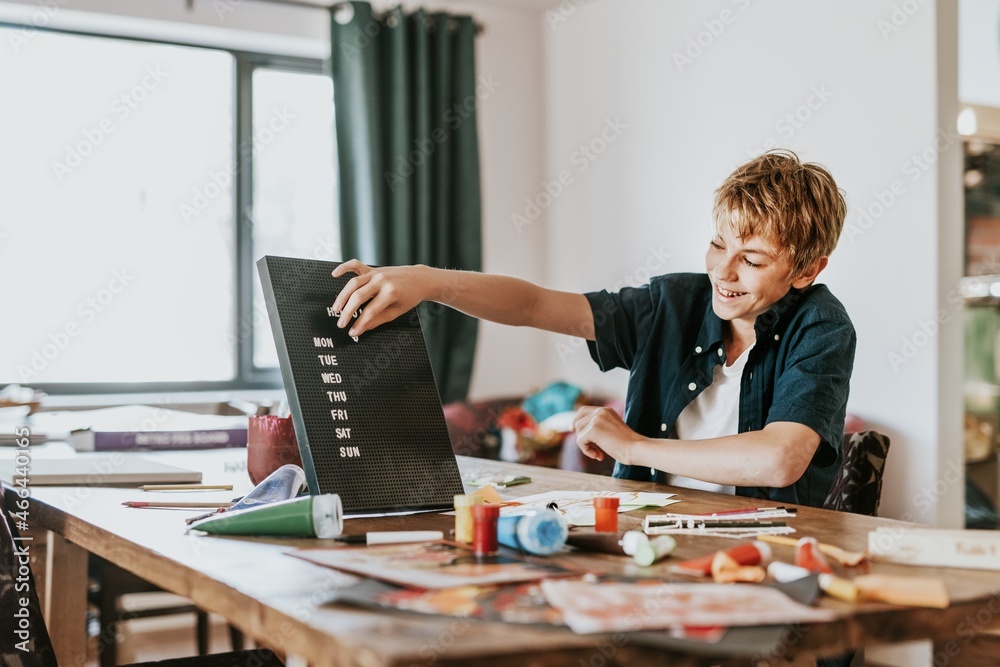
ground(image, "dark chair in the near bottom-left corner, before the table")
xmin=0 ymin=486 xmax=284 ymax=667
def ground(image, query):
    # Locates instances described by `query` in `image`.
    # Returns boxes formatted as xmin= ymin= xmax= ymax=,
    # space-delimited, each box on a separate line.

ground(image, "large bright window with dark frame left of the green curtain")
xmin=0 ymin=27 xmax=340 ymax=392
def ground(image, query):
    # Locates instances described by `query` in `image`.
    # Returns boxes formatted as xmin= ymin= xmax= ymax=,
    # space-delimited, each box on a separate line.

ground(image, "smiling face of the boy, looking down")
xmin=705 ymin=224 xmax=826 ymax=334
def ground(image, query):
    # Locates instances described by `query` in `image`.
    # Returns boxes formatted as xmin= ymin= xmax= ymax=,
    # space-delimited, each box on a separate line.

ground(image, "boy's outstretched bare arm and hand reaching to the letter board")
xmin=333 ymin=259 xmax=594 ymax=340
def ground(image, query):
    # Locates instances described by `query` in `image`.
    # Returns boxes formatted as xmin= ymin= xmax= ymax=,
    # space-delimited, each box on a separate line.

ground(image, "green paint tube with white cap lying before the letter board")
xmin=190 ymin=493 xmax=344 ymax=538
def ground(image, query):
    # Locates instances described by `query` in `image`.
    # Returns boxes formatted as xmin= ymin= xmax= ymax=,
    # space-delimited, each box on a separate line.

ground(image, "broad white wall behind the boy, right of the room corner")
xmin=546 ymin=0 xmax=962 ymax=526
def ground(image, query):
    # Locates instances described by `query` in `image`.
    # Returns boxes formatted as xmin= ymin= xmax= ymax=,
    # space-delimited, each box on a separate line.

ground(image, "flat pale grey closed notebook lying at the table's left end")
xmin=0 ymin=453 xmax=201 ymax=488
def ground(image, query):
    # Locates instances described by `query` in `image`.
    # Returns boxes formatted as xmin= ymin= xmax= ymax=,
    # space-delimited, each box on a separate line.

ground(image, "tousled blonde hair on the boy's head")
xmin=712 ymin=150 xmax=847 ymax=276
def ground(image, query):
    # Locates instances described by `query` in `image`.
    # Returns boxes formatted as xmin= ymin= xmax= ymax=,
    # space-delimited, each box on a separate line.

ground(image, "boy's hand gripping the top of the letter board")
xmin=333 ymin=259 xmax=433 ymax=336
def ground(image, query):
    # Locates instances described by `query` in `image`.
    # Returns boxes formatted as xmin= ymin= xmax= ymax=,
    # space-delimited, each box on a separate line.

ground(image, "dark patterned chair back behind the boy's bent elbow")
xmin=823 ymin=431 xmax=889 ymax=516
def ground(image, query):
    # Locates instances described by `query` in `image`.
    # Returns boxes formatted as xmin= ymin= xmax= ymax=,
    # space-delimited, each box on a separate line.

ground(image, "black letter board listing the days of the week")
xmin=257 ymin=256 xmax=463 ymax=514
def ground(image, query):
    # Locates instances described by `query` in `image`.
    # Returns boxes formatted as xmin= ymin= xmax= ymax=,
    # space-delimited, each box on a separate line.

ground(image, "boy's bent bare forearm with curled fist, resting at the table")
xmin=574 ymin=407 xmax=820 ymax=488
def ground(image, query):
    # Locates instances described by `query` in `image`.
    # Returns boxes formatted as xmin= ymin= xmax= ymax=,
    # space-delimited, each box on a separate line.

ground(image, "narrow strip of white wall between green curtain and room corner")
xmin=435 ymin=2 xmax=549 ymax=398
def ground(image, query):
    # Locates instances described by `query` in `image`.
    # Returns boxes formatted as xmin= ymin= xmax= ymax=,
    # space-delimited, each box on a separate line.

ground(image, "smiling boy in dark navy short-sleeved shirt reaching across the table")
xmin=333 ymin=151 xmax=856 ymax=506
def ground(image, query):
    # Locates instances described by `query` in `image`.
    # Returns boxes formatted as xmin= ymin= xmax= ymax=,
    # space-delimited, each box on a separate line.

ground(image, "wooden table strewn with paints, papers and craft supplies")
xmin=11 ymin=450 xmax=1000 ymax=667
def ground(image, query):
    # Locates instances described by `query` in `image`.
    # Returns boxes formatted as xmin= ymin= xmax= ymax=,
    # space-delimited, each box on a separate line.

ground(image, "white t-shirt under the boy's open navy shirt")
xmin=667 ymin=345 xmax=753 ymax=495
